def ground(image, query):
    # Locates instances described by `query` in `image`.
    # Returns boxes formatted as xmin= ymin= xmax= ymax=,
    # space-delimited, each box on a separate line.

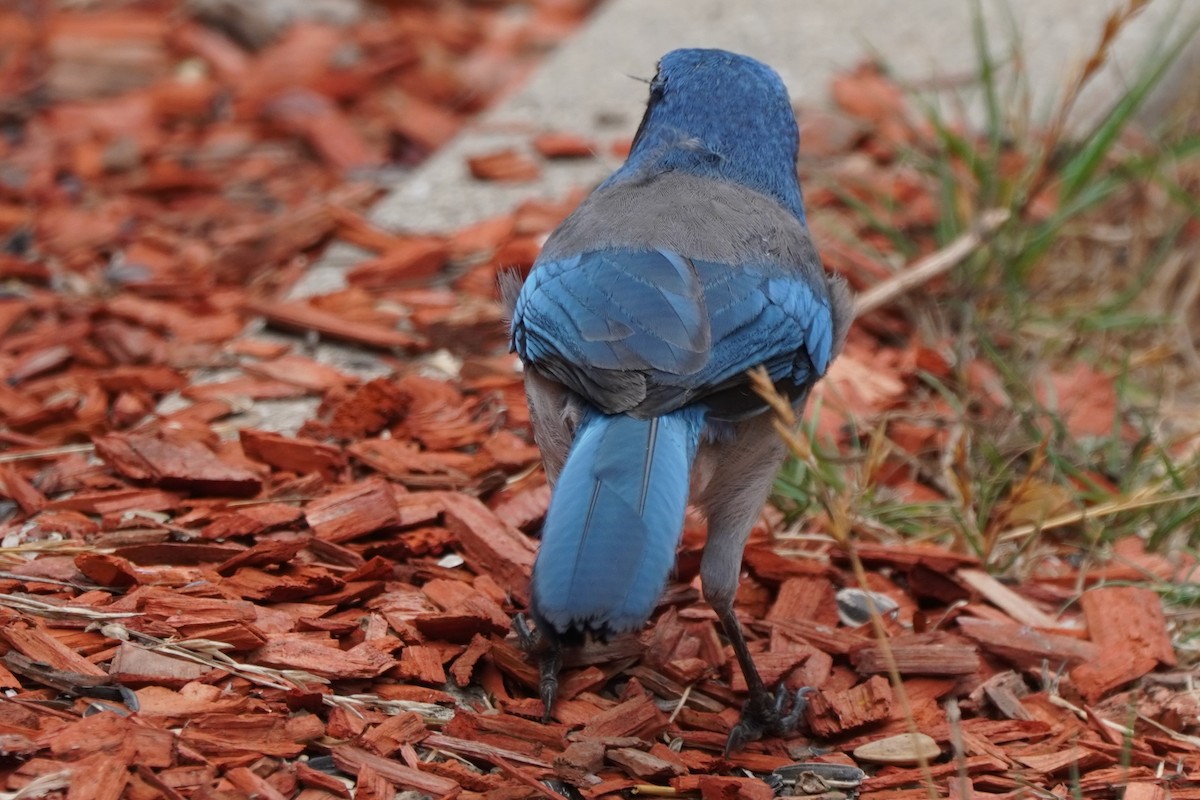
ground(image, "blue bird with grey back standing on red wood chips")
xmin=500 ymin=48 xmax=853 ymax=750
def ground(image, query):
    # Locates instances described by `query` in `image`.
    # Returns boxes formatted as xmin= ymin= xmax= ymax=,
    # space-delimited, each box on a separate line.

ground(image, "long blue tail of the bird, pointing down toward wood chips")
xmin=532 ymin=407 xmax=704 ymax=634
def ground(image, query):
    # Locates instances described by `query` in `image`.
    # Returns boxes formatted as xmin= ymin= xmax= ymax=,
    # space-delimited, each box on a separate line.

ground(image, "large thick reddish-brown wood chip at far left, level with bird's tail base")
xmin=95 ymin=433 xmax=263 ymax=497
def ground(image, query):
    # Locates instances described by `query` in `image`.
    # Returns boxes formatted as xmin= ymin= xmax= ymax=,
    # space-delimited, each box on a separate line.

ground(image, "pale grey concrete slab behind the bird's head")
xmin=364 ymin=0 xmax=1200 ymax=237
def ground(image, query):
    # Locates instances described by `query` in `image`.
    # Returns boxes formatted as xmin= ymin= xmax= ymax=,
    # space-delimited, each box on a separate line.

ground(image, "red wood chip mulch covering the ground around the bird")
xmin=0 ymin=6 xmax=1200 ymax=800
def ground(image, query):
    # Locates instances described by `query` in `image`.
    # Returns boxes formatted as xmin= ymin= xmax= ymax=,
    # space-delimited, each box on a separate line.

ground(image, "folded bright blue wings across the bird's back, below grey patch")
xmin=512 ymin=249 xmax=833 ymax=414
